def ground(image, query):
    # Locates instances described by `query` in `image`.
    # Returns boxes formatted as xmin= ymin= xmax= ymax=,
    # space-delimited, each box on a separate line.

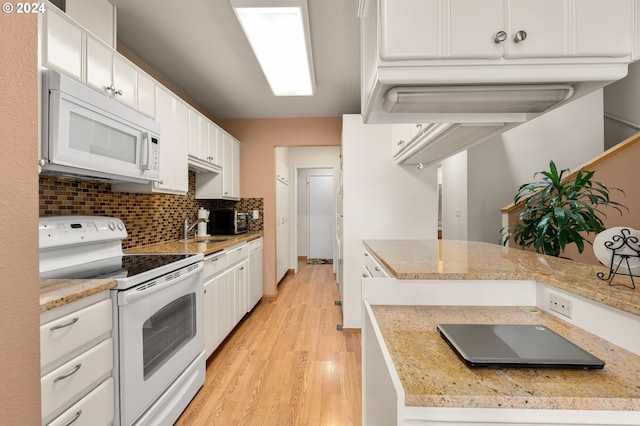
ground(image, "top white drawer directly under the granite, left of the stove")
xmin=40 ymin=299 xmax=112 ymax=373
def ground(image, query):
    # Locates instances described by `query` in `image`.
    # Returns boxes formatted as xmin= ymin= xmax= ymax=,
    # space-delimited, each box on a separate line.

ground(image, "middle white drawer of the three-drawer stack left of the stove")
xmin=40 ymin=338 xmax=113 ymax=423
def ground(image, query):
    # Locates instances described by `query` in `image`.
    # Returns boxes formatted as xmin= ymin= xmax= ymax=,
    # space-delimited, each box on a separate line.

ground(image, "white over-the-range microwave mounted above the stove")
xmin=40 ymin=70 xmax=160 ymax=183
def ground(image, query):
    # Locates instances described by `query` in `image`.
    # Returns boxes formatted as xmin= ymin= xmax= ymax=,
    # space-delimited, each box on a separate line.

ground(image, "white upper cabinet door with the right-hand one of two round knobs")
xmin=502 ymin=0 xmax=564 ymax=58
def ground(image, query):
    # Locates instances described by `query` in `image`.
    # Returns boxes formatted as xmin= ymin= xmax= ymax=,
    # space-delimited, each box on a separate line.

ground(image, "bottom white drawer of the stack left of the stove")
xmin=49 ymin=377 xmax=114 ymax=426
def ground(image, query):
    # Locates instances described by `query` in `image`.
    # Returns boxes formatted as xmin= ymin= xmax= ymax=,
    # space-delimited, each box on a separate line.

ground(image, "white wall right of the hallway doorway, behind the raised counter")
xmin=342 ymin=115 xmax=438 ymax=328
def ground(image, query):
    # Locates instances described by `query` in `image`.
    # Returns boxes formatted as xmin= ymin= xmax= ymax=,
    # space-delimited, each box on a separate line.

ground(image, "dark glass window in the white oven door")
xmin=142 ymin=293 xmax=197 ymax=381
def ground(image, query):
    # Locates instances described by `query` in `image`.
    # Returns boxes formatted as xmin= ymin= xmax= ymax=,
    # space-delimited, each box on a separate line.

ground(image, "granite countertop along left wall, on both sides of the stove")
xmin=40 ymin=232 xmax=263 ymax=313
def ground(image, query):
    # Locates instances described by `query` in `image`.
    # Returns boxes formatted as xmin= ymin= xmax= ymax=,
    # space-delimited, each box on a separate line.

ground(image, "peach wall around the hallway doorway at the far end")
xmin=218 ymin=117 xmax=342 ymax=295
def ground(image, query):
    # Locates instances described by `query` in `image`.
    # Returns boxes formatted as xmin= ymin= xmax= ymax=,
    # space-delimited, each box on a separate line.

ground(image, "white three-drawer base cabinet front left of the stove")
xmin=40 ymin=292 xmax=114 ymax=425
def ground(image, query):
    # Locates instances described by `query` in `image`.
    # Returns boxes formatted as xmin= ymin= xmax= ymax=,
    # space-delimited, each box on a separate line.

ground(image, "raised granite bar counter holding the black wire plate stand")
xmin=364 ymin=240 xmax=640 ymax=315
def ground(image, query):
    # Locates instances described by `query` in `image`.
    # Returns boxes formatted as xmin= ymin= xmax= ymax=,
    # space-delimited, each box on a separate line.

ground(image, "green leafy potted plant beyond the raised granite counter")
xmin=503 ymin=161 xmax=626 ymax=256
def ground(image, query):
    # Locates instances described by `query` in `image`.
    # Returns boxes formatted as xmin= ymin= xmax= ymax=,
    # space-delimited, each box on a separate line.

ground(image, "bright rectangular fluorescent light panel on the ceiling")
xmin=230 ymin=0 xmax=315 ymax=96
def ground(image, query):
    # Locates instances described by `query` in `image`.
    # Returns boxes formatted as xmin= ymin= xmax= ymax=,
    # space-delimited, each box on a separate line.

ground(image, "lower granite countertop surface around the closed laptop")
xmin=372 ymin=305 xmax=640 ymax=411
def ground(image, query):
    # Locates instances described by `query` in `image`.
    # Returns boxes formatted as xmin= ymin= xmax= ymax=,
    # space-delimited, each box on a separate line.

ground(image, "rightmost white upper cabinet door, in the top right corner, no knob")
xmin=575 ymin=0 xmax=633 ymax=57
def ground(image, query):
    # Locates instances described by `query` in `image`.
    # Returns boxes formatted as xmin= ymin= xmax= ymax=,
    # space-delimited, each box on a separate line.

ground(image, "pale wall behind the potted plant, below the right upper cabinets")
xmin=460 ymin=90 xmax=604 ymax=243
